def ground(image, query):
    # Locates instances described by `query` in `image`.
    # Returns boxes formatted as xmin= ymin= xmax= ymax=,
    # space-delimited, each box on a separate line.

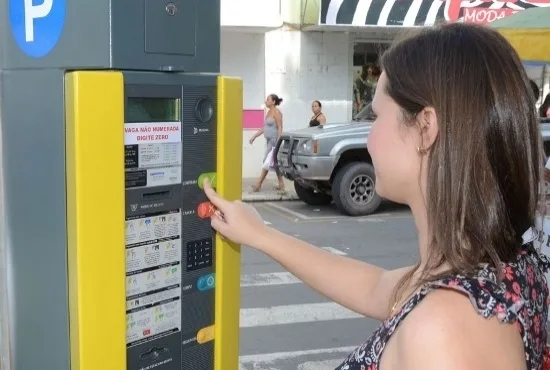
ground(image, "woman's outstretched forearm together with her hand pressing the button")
xmin=204 ymin=179 xmax=411 ymax=320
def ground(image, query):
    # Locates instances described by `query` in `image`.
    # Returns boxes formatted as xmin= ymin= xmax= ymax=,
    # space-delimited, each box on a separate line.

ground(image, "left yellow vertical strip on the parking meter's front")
xmin=65 ymin=71 xmax=126 ymax=370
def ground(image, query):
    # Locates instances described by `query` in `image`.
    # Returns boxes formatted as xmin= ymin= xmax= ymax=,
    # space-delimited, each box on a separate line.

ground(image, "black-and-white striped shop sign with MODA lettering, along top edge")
xmin=320 ymin=0 xmax=550 ymax=27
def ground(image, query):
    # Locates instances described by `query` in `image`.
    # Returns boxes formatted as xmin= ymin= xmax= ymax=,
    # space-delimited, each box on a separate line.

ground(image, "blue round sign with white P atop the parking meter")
xmin=9 ymin=0 xmax=66 ymax=58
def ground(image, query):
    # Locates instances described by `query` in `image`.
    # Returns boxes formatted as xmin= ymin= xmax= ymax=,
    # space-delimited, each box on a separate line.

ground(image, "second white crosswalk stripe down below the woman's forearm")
xmin=240 ymin=302 xmax=363 ymax=328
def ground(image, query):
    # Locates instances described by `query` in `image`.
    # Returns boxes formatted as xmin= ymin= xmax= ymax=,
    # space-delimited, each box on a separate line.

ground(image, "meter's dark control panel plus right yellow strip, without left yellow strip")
xmin=123 ymin=71 xmax=242 ymax=370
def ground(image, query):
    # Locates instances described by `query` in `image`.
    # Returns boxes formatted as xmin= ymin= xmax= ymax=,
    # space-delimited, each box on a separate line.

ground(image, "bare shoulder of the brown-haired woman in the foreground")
xmin=395 ymin=289 xmax=526 ymax=370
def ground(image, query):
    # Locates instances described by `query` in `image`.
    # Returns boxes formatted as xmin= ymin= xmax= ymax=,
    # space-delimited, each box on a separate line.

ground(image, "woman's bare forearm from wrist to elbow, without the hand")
xmin=254 ymin=228 xmax=411 ymax=320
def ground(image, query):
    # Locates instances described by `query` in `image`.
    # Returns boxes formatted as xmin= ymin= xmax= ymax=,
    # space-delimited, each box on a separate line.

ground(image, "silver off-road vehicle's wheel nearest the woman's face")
xmin=332 ymin=162 xmax=382 ymax=216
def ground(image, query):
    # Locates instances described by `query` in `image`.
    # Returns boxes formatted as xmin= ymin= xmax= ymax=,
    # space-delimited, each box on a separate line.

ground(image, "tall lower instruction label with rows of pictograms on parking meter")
xmin=126 ymin=209 xmax=182 ymax=347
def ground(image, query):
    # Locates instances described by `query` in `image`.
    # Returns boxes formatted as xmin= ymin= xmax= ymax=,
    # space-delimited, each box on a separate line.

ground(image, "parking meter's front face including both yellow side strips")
xmin=66 ymin=71 xmax=242 ymax=370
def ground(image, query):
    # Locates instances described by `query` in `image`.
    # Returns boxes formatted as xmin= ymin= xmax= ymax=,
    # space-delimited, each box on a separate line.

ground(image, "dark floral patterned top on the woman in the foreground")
xmin=336 ymin=243 xmax=550 ymax=370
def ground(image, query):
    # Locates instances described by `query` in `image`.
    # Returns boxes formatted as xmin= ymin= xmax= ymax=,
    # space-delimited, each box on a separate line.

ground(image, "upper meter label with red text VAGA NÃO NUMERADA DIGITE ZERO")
xmin=124 ymin=122 xmax=182 ymax=188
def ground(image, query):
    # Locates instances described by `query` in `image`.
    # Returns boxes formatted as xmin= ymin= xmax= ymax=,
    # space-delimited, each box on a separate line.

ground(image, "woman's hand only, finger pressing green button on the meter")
xmin=204 ymin=179 xmax=267 ymax=247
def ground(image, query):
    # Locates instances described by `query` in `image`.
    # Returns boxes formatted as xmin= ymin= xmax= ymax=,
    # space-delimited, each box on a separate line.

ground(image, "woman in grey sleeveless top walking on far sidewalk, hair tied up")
xmin=250 ymin=94 xmax=285 ymax=192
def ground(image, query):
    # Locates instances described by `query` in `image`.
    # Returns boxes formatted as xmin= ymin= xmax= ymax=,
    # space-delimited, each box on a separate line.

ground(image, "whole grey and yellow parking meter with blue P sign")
xmin=0 ymin=0 xmax=242 ymax=370
